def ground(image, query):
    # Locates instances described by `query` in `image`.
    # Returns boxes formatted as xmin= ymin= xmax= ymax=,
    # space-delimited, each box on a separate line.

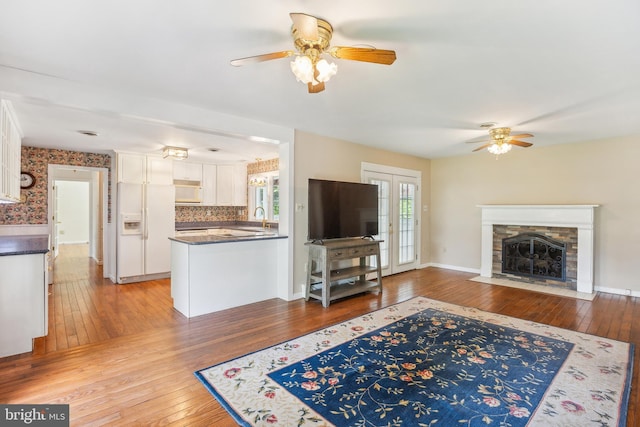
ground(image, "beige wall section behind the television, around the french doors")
xmin=293 ymin=131 xmax=430 ymax=292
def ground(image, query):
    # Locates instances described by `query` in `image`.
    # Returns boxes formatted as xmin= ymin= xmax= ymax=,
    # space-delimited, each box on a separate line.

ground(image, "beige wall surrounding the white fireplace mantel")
xmin=430 ymin=137 xmax=640 ymax=291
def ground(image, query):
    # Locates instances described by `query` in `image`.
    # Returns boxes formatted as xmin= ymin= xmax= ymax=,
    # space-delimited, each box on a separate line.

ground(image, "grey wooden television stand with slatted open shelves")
xmin=304 ymin=238 xmax=382 ymax=307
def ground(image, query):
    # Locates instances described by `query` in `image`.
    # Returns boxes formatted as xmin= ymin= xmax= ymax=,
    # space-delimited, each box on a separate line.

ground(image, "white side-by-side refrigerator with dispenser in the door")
xmin=116 ymin=183 xmax=175 ymax=283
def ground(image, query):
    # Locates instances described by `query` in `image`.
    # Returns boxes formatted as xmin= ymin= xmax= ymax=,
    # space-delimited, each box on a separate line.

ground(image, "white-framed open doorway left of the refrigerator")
xmin=48 ymin=165 xmax=108 ymax=282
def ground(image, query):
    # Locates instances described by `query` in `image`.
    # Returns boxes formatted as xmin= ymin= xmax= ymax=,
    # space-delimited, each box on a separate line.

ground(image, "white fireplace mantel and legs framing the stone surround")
xmin=478 ymin=205 xmax=599 ymax=293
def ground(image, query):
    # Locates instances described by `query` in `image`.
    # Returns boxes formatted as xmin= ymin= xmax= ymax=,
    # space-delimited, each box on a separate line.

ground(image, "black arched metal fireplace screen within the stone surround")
xmin=502 ymin=233 xmax=567 ymax=282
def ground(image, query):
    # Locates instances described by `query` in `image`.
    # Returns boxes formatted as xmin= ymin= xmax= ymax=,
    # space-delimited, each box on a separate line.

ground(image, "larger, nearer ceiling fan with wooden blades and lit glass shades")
xmin=231 ymin=13 xmax=396 ymax=93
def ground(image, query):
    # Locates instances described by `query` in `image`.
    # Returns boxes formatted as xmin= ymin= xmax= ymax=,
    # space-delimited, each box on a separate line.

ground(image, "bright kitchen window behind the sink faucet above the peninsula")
xmin=249 ymin=171 xmax=280 ymax=222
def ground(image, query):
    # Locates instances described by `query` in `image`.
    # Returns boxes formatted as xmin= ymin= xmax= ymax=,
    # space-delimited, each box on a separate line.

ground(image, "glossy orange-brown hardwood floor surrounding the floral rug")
xmin=0 ymin=246 xmax=640 ymax=426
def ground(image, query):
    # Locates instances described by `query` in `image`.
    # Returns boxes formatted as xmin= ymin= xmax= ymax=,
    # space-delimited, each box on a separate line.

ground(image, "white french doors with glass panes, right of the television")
xmin=362 ymin=169 xmax=420 ymax=276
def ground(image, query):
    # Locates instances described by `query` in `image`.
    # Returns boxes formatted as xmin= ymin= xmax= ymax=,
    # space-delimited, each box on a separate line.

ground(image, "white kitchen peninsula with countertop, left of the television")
xmin=170 ymin=226 xmax=287 ymax=317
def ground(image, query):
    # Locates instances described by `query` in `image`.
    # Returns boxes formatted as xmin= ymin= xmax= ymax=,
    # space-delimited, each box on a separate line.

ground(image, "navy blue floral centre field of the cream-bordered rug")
xmin=269 ymin=309 xmax=573 ymax=427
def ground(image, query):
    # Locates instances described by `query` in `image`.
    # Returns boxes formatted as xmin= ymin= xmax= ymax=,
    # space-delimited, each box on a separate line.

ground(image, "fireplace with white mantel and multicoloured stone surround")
xmin=479 ymin=205 xmax=597 ymax=293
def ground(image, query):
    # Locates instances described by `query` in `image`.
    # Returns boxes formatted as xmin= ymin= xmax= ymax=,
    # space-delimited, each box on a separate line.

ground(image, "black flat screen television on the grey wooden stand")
xmin=307 ymin=179 xmax=378 ymax=241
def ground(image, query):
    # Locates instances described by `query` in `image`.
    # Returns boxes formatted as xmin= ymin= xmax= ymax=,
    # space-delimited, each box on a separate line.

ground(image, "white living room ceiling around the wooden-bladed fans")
xmin=0 ymin=0 xmax=640 ymax=161
